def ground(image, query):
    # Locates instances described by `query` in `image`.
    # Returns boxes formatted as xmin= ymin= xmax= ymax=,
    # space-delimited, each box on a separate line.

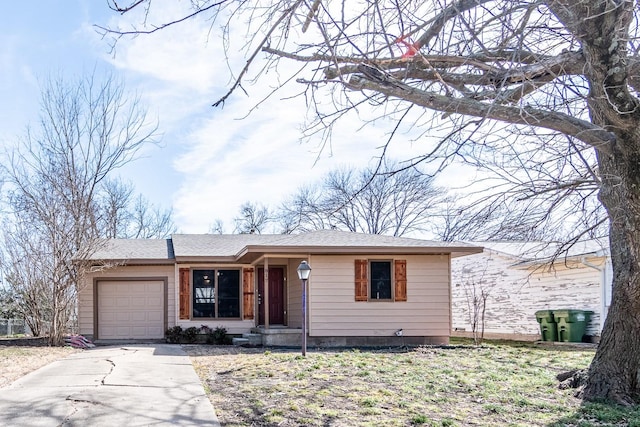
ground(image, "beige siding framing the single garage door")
xmin=78 ymin=265 xmax=176 ymax=342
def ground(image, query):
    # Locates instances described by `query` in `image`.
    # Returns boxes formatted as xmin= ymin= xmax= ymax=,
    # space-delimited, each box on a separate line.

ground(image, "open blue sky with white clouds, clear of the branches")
xmin=0 ymin=0 xmax=450 ymax=233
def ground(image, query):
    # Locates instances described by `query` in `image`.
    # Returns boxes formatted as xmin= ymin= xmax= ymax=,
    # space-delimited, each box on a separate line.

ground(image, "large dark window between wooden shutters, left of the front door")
xmin=192 ymin=269 xmax=240 ymax=318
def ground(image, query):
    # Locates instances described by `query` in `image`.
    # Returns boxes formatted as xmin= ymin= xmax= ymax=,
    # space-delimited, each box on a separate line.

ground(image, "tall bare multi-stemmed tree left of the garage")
xmin=3 ymin=75 xmax=156 ymax=345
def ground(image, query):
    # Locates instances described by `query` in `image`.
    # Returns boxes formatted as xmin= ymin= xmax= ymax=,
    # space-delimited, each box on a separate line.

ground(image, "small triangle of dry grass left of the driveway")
xmin=0 ymin=345 xmax=78 ymax=387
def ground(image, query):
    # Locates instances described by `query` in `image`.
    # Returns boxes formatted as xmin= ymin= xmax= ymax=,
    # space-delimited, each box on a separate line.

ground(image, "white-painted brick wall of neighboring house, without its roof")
xmin=452 ymin=251 xmax=605 ymax=335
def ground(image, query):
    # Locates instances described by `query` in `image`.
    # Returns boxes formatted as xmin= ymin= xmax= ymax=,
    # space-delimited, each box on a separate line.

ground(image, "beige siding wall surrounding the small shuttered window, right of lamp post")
xmin=309 ymin=254 xmax=450 ymax=337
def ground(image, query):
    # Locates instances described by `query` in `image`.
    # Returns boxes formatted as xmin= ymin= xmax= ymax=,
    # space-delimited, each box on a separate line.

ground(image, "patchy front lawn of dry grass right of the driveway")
xmin=185 ymin=344 xmax=640 ymax=427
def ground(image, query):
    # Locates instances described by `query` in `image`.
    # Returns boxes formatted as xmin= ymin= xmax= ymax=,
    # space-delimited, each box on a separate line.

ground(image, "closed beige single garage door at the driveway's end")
xmin=98 ymin=281 xmax=164 ymax=340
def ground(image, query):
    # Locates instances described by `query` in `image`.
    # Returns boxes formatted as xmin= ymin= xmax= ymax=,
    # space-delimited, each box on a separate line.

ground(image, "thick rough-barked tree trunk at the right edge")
xmin=576 ymin=0 xmax=640 ymax=405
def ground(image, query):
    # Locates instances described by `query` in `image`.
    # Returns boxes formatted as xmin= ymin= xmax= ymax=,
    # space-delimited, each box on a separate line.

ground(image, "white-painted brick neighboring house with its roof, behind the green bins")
xmin=451 ymin=240 xmax=612 ymax=340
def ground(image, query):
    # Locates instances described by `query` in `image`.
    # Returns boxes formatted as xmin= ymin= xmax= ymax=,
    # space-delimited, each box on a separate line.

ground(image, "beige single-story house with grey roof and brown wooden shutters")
xmin=78 ymin=230 xmax=482 ymax=346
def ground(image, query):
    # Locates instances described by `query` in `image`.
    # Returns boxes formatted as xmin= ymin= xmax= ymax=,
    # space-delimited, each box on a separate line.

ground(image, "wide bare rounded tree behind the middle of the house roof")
xmin=280 ymin=163 xmax=444 ymax=236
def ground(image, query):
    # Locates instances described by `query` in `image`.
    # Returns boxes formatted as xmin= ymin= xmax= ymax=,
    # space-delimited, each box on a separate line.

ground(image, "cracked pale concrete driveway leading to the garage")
xmin=0 ymin=344 xmax=220 ymax=427
